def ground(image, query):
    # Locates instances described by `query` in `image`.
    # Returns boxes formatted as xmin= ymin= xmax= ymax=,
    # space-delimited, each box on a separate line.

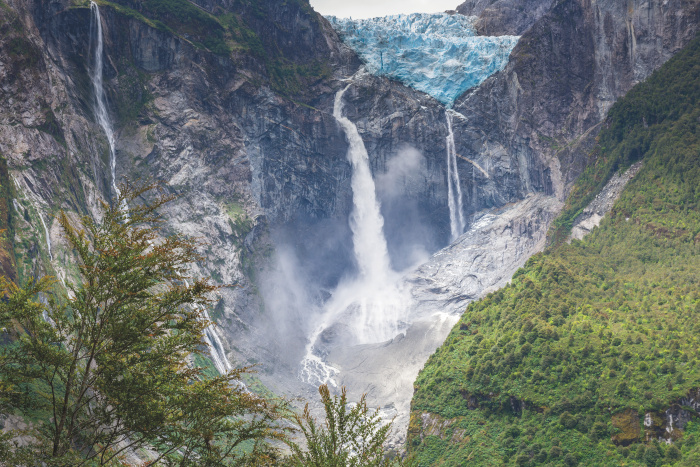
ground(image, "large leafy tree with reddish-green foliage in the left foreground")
xmin=0 ymin=186 xmax=285 ymax=466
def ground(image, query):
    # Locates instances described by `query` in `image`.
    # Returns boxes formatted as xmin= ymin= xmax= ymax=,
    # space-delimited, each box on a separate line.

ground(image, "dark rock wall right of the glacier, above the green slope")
xmin=448 ymin=0 xmax=700 ymax=208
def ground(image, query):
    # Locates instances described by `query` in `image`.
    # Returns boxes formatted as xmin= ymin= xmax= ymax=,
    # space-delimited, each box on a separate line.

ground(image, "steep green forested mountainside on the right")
xmin=409 ymin=33 xmax=700 ymax=466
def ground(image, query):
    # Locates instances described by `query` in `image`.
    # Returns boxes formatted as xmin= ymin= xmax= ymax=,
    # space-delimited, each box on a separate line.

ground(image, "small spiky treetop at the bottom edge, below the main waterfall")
xmin=291 ymin=384 xmax=401 ymax=467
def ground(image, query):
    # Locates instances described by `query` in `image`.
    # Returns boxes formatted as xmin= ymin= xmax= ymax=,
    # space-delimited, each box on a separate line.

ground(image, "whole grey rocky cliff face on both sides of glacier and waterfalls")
xmin=0 ymin=0 xmax=698 ymax=454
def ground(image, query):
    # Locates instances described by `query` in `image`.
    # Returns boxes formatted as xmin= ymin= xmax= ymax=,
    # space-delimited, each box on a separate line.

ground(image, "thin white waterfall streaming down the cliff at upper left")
xmin=88 ymin=2 xmax=120 ymax=198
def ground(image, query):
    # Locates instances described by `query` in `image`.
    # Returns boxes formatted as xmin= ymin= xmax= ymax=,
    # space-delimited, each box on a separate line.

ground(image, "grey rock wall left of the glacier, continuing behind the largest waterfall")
xmin=0 ymin=1 xmax=464 ymax=371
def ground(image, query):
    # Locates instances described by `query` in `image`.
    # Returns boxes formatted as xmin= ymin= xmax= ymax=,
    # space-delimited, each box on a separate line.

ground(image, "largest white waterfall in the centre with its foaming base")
xmin=300 ymin=81 xmax=408 ymax=385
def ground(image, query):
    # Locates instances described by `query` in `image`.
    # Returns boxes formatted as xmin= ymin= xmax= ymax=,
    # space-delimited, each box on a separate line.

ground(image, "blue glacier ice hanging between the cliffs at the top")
xmin=327 ymin=13 xmax=520 ymax=108
